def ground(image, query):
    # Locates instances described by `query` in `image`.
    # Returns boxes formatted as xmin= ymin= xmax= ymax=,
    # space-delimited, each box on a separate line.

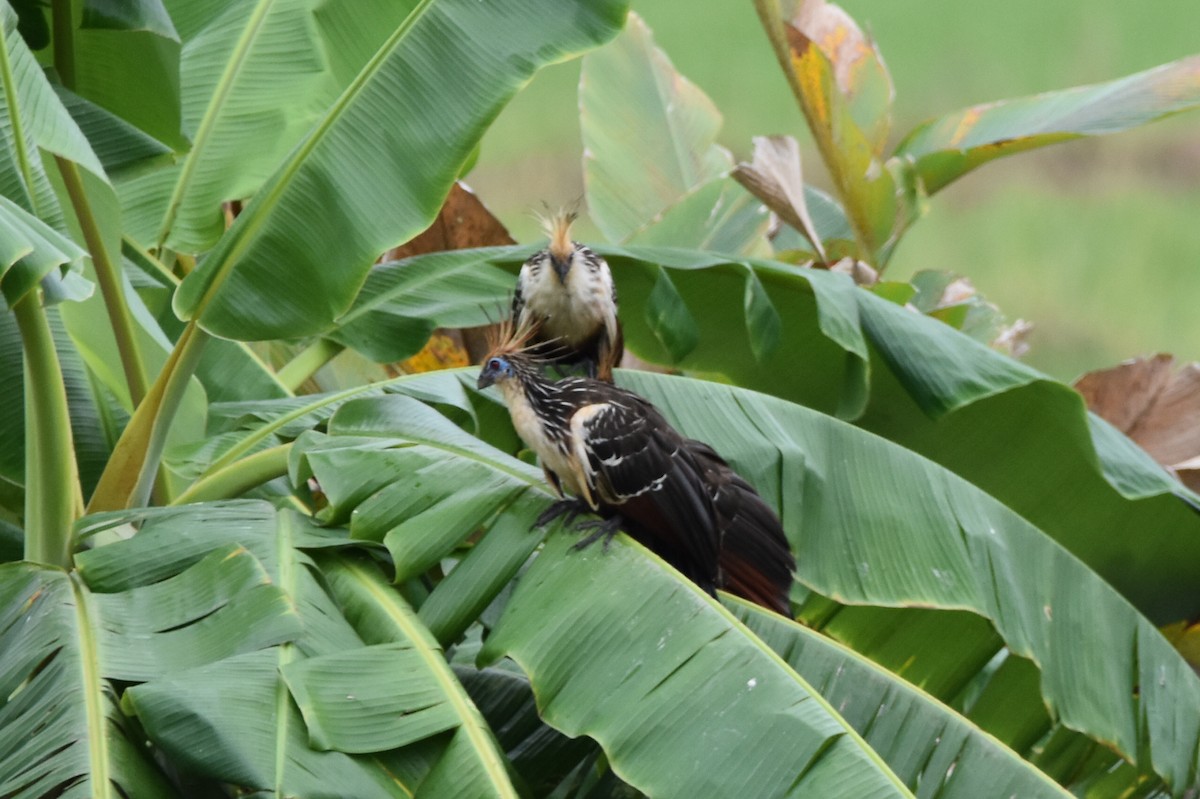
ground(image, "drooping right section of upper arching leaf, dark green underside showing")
xmin=857 ymin=292 xmax=1200 ymax=624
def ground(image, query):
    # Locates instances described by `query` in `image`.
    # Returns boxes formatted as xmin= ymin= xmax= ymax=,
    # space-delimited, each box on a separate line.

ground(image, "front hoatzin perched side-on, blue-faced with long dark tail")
xmin=479 ymin=340 xmax=794 ymax=615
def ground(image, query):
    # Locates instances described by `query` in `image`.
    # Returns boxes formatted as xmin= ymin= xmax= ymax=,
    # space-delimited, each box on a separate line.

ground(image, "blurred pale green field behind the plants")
xmin=467 ymin=0 xmax=1200 ymax=380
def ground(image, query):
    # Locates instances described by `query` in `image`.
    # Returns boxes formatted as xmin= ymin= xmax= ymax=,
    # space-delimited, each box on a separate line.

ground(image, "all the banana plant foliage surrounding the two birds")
xmin=0 ymin=0 xmax=1200 ymax=797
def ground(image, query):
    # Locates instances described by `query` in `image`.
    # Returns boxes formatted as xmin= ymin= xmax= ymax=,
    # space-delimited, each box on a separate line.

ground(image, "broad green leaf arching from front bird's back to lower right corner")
xmin=622 ymin=372 xmax=1200 ymax=789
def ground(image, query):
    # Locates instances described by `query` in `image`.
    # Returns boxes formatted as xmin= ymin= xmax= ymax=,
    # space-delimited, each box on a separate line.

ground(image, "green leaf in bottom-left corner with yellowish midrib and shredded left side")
xmin=0 ymin=506 xmax=300 ymax=798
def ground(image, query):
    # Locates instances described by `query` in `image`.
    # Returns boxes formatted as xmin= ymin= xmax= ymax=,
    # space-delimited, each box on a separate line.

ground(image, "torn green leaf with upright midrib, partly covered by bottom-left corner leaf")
xmin=78 ymin=501 xmax=430 ymax=798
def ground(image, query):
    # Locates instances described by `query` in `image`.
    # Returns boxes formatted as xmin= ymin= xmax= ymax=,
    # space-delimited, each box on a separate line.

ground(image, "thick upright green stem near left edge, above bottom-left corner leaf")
xmin=12 ymin=289 xmax=79 ymax=569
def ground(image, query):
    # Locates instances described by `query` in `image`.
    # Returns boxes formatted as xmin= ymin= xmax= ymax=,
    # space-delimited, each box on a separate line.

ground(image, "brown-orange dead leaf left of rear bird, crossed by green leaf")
xmin=379 ymin=181 xmax=516 ymax=364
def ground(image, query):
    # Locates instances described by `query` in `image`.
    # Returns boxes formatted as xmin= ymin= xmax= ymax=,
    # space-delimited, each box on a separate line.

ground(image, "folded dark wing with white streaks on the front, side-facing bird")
xmin=570 ymin=388 xmax=720 ymax=591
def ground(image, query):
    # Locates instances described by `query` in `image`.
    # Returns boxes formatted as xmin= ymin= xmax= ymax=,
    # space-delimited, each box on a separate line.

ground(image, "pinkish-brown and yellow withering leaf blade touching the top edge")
xmin=785 ymin=0 xmax=895 ymax=156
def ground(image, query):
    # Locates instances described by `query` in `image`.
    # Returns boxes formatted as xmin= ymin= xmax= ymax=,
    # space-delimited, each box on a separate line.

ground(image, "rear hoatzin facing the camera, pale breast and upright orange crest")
xmin=512 ymin=212 xmax=624 ymax=383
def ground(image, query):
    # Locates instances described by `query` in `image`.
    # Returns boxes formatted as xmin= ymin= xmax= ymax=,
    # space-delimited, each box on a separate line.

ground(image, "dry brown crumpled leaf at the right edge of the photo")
xmin=1075 ymin=354 xmax=1200 ymax=475
